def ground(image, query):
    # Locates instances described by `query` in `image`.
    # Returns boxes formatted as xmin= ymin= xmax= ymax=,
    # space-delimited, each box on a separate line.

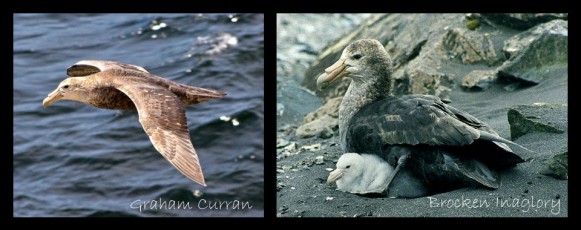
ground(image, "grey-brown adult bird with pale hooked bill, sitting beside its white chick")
xmin=317 ymin=39 xmax=530 ymax=197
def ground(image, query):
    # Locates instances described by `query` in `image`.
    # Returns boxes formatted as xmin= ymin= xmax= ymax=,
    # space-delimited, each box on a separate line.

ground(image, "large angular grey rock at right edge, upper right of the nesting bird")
xmin=497 ymin=20 xmax=569 ymax=84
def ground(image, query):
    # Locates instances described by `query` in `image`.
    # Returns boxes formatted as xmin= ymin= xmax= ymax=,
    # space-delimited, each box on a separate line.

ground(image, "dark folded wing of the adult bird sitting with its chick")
xmin=346 ymin=95 xmax=530 ymax=152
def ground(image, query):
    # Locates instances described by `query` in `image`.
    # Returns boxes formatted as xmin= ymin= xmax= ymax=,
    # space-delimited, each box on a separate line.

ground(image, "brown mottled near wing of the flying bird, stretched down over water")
xmin=113 ymin=77 xmax=206 ymax=186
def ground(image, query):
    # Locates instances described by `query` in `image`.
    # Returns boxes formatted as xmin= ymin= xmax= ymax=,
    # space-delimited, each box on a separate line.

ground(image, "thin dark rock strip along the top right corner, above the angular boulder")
xmin=481 ymin=13 xmax=568 ymax=30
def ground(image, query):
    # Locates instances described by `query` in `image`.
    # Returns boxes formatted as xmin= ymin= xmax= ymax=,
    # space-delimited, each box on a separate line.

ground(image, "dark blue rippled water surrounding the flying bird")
xmin=13 ymin=14 xmax=264 ymax=217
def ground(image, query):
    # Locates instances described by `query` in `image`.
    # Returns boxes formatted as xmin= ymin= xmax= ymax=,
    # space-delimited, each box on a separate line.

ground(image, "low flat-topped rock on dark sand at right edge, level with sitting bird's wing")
xmin=508 ymin=103 xmax=567 ymax=140
